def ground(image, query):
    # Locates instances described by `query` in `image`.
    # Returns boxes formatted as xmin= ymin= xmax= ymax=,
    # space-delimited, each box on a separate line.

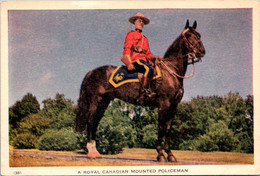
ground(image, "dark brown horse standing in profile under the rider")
xmin=75 ymin=20 xmax=205 ymax=162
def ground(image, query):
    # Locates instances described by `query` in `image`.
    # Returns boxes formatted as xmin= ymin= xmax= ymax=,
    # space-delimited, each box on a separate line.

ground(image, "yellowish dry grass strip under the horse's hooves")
xmin=10 ymin=148 xmax=254 ymax=167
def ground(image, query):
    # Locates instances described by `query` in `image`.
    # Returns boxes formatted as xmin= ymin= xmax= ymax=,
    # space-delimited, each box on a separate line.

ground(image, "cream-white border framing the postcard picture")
xmin=1 ymin=0 xmax=260 ymax=175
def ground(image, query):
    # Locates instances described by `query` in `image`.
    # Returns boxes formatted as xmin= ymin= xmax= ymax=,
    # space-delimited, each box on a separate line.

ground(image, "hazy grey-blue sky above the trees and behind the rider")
xmin=8 ymin=8 xmax=253 ymax=106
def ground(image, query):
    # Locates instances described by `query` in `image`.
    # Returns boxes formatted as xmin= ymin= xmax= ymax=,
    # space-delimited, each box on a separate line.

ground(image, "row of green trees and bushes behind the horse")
xmin=9 ymin=92 xmax=254 ymax=154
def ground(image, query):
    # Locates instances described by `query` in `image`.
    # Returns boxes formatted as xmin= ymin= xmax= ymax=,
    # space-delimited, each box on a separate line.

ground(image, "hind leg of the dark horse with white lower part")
xmin=86 ymin=96 xmax=110 ymax=158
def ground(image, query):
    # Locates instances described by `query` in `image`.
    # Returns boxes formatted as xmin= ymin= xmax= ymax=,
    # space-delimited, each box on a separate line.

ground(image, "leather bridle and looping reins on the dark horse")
xmin=159 ymin=28 xmax=202 ymax=79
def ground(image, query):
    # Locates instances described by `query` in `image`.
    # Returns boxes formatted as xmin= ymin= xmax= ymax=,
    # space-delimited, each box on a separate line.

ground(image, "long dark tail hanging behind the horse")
xmin=74 ymin=74 xmax=89 ymax=132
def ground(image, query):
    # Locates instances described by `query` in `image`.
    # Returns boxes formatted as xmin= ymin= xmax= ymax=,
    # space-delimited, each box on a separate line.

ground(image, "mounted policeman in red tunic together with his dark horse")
xmin=75 ymin=13 xmax=206 ymax=162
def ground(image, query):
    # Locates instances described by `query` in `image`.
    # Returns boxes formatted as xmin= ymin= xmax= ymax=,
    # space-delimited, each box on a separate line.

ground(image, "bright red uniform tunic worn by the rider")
xmin=123 ymin=31 xmax=153 ymax=63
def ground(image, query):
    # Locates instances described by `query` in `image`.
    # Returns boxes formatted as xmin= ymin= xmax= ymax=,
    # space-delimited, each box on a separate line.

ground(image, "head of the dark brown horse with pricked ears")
xmin=181 ymin=20 xmax=206 ymax=58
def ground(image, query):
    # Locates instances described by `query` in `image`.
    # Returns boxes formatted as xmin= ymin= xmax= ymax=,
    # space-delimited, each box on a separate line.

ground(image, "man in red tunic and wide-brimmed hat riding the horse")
xmin=121 ymin=12 xmax=160 ymax=101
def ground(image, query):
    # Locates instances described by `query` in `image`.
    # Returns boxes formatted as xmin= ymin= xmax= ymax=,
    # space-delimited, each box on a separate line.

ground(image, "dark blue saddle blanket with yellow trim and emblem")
xmin=109 ymin=65 xmax=161 ymax=88
